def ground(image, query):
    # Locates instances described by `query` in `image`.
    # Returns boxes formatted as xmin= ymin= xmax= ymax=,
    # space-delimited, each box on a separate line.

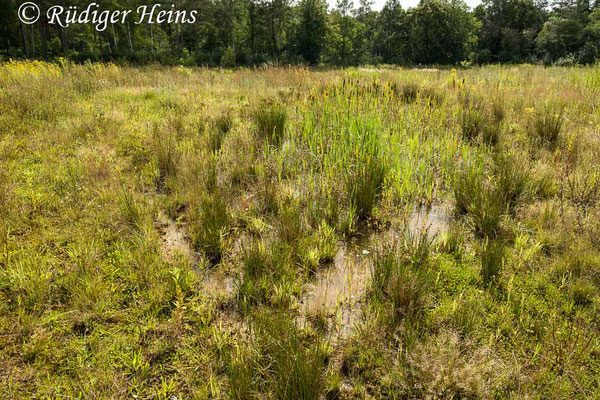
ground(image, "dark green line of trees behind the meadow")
xmin=0 ymin=0 xmax=600 ymax=67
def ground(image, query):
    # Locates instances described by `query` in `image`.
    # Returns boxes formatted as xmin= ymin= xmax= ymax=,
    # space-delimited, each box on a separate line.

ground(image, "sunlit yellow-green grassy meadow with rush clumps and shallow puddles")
xmin=0 ymin=62 xmax=600 ymax=400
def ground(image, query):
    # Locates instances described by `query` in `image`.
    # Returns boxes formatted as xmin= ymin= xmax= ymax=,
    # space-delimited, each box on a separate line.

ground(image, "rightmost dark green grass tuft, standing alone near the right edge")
xmin=528 ymin=105 xmax=564 ymax=150
